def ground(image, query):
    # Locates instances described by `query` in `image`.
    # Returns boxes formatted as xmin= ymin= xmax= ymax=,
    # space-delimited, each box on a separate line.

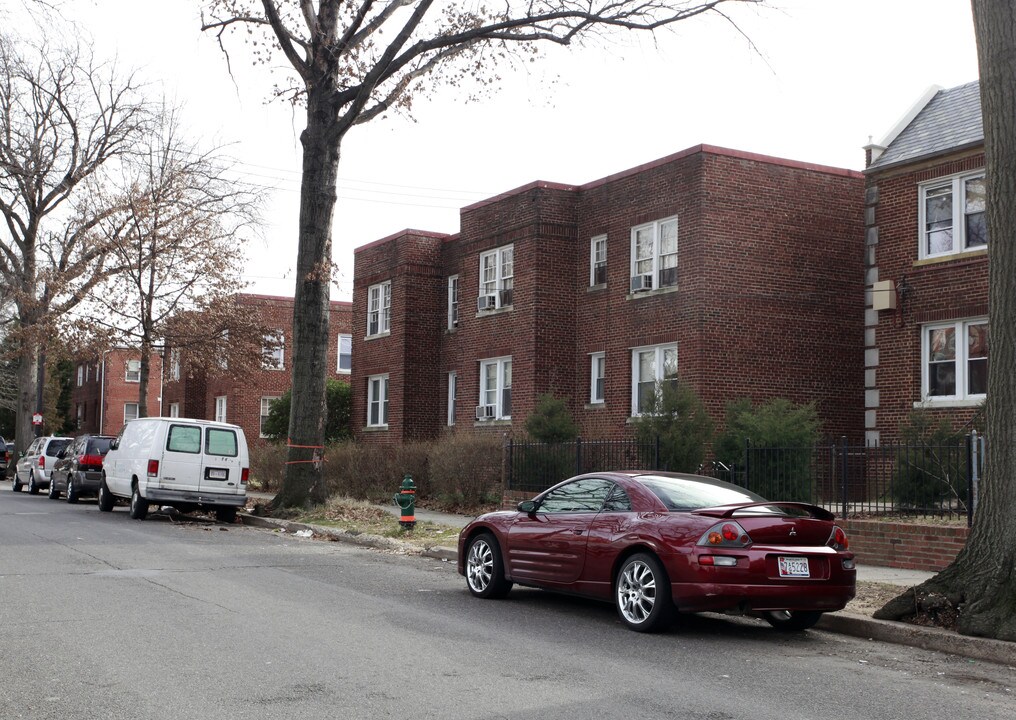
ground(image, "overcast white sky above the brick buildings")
xmin=49 ymin=0 xmax=977 ymax=300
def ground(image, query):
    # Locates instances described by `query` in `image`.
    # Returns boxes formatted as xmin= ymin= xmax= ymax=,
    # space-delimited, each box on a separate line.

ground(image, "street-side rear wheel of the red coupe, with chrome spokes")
xmin=614 ymin=552 xmax=674 ymax=633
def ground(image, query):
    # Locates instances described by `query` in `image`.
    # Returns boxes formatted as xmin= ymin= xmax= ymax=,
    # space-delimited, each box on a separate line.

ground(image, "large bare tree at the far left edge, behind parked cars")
xmin=0 ymin=32 xmax=148 ymax=449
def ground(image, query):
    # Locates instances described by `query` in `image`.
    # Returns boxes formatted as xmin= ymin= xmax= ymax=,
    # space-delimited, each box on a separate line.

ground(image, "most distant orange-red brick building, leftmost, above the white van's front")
xmin=71 ymin=347 xmax=163 ymax=435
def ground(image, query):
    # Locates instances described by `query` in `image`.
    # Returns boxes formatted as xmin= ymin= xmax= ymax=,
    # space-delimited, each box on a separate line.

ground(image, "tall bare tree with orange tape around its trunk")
xmin=203 ymin=0 xmax=763 ymax=507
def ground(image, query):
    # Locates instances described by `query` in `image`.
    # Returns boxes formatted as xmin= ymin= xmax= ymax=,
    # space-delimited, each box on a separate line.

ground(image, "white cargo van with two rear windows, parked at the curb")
xmin=99 ymin=417 xmax=250 ymax=523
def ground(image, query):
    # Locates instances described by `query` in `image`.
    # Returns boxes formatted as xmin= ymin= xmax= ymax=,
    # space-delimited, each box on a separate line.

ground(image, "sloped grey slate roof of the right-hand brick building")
xmin=869 ymin=81 xmax=985 ymax=170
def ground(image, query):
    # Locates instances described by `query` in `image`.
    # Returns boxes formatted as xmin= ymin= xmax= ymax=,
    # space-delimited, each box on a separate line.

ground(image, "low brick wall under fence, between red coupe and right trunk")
xmin=836 ymin=518 xmax=967 ymax=571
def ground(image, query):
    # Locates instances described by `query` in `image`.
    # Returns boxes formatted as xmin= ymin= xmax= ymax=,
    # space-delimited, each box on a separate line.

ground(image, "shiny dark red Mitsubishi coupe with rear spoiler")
xmin=458 ymin=471 xmax=856 ymax=632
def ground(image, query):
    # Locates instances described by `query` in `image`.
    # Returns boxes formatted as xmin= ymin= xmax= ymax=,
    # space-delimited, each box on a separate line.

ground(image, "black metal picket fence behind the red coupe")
xmin=505 ymin=433 xmax=986 ymax=523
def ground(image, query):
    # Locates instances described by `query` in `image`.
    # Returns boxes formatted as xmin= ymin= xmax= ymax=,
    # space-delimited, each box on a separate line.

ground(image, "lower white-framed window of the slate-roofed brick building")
xmin=922 ymin=318 xmax=988 ymax=402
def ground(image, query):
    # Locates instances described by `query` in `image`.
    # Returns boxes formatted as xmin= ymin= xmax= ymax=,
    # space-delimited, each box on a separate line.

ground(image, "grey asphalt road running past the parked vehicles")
xmin=0 ymin=483 xmax=1016 ymax=720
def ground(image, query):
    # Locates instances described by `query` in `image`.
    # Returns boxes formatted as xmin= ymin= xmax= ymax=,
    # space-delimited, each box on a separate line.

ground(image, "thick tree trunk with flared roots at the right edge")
xmin=875 ymin=0 xmax=1016 ymax=641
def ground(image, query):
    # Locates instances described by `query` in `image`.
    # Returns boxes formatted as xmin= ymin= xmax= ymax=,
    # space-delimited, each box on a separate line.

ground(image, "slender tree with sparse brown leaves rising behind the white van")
xmin=75 ymin=109 xmax=262 ymax=417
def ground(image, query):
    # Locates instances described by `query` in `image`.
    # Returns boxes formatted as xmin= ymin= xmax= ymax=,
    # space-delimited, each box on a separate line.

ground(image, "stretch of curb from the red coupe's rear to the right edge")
xmin=815 ymin=612 xmax=1016 ymax=667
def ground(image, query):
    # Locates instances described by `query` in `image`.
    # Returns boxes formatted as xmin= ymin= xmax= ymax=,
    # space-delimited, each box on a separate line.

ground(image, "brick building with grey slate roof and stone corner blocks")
xmin=865 ymin=77 xmax=989 ymax=442
